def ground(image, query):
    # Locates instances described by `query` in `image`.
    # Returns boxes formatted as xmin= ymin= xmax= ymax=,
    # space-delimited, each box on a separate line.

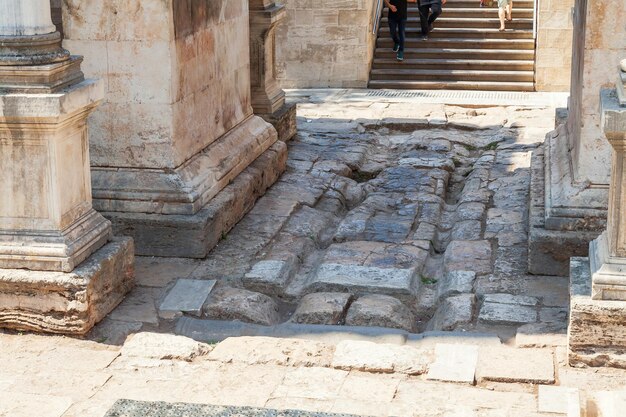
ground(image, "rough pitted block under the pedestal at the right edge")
xmin=567 ymin=257 xmax=626 ymax=369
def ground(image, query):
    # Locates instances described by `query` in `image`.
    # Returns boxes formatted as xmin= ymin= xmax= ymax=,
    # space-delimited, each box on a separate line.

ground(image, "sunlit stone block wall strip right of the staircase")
xmin=535 ymin=0 xmax=574 ymax=91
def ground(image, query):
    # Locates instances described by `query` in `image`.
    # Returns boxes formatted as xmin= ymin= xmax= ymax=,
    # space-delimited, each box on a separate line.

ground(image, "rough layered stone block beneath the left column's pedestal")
xmin=0 ymin=238 xmax=134 ymax=335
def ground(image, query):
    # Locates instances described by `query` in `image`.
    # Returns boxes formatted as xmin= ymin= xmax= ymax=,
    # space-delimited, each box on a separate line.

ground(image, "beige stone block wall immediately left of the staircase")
xmin=276 ymin=0 xmax=376 ymax=88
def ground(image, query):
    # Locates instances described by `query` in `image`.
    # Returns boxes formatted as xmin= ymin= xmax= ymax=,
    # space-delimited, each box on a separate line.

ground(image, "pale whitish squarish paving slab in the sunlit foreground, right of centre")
xmin=426 ymin=344 xmax=478 ymax=384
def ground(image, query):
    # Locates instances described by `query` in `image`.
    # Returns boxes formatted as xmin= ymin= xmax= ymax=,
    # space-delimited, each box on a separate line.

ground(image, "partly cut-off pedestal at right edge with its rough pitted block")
xmin=568 ymin=79 xmax=626 ymax=368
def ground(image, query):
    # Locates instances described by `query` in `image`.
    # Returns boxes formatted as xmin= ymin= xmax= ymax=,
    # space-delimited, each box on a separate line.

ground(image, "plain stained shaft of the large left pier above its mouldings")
xmin=63 ymin=0 xmax=252 ymax=168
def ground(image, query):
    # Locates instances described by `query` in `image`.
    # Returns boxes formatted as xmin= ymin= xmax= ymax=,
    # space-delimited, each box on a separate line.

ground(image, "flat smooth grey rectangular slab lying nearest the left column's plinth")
xmin=159 ymin=279 xmax=217 ymax=319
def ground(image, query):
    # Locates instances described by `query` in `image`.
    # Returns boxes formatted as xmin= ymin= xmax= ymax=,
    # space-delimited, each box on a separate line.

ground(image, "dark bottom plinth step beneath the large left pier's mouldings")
xmin=102 ymin=141 xmax=287 ymax=258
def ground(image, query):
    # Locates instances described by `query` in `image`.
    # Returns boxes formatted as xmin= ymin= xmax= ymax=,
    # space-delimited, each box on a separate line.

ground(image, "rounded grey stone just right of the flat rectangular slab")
xmin=204 ymin=287 xmax=280 ymax=326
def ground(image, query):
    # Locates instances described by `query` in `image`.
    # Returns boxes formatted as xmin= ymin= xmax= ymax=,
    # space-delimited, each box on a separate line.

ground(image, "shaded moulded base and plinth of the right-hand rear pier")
xmin=528 ymin=125 xmax=608 ymax=276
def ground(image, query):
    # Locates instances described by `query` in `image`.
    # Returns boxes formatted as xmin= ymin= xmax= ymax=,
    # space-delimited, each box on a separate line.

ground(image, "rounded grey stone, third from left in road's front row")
xmin=346 ymin=294 xmax=415 ymax=331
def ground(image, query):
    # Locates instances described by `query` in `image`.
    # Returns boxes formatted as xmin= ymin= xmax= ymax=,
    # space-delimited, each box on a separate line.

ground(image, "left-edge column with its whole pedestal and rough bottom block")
xmin=0 ymin=0 xmax=133 ymax=334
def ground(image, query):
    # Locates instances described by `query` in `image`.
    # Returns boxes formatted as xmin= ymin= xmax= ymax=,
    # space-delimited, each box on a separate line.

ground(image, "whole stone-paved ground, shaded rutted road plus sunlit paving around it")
xmin=0 ymin=95 xmax=626 ymax=417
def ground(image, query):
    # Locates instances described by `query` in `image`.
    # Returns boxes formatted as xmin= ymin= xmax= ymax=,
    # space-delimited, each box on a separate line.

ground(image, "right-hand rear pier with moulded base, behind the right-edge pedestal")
xmin=528 ymin=0 xmax=626 ymax=275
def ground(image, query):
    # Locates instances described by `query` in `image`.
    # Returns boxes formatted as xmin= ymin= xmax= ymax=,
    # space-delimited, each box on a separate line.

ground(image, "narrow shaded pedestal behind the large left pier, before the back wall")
xmin=249 ymin=0 xmax=297 ymax=142
